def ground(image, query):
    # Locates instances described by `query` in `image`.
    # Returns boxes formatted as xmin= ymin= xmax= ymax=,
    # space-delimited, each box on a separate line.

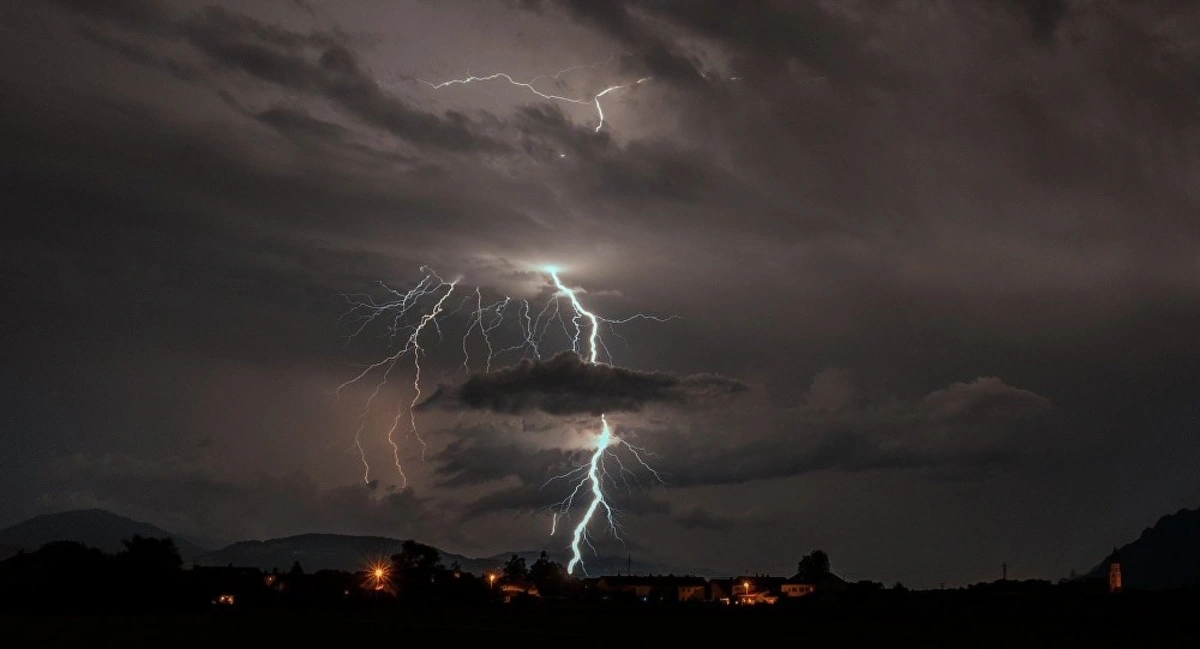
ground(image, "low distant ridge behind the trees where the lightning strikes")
xmin=193 ymin=534 xmax=708 ymax=576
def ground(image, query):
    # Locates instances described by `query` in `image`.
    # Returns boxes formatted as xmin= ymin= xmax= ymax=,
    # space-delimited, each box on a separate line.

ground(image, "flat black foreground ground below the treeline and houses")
xmin=0 ymin=599 xmax=1200 ymax=649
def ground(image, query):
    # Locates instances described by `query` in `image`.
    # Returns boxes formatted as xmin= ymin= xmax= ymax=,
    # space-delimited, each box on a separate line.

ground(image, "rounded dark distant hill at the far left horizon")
xmin=0 ymin=510 xmax=208 ymax=561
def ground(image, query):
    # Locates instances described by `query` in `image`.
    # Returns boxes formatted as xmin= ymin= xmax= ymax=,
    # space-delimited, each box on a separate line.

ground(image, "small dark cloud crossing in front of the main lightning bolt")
xmin=421 ymin=351 xmax=746 ymax=415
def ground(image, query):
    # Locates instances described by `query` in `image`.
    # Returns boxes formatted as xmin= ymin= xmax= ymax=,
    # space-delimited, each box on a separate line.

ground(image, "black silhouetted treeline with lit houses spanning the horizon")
xmin=0 ymin=536 xmax=1185 ymax=618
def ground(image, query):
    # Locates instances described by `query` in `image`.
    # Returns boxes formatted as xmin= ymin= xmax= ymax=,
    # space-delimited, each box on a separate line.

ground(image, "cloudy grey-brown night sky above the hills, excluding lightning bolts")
xmin=0 ymin=0 xmax=1200 ymax=587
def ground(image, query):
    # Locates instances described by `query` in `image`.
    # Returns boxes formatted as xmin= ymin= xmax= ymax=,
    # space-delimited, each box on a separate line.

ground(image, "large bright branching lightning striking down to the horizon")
xmin=338 ymin=266 xmax=674 ymax=573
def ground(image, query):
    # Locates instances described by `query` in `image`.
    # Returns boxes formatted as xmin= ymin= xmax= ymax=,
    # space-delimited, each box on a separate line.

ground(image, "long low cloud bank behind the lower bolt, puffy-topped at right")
xmin=434 ymin=368 xmax=1054 ymax=503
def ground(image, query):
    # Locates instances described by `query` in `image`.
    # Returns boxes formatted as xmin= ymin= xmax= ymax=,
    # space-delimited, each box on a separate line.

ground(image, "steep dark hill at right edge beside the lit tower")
xmin=1088 ymin=509 xmax=1200 ymax=590
